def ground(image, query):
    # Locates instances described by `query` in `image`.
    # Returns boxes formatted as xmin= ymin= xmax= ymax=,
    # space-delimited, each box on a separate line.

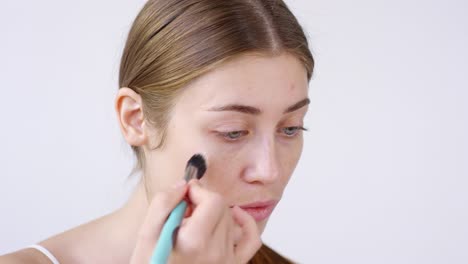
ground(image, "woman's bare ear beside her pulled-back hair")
xmin=115 ymin=87 xmax=148 ymax=146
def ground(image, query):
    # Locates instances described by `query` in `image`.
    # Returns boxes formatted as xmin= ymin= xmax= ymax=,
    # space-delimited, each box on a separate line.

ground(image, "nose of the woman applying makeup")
xmin=245 ymin=138 xmax=280 ymax=184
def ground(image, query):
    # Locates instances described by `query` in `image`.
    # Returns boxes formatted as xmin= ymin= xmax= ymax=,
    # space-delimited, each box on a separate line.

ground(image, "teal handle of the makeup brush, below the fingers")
xmin=150 ymin=201 xmax=187 ymax=264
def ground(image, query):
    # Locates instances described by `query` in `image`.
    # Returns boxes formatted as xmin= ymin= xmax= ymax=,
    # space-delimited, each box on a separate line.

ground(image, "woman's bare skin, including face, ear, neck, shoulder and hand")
xmin=0 ymin=53 xmax=308 ymax=263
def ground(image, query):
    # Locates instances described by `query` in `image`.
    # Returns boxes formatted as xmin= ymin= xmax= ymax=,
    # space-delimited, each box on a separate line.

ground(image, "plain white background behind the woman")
xmin=0 ymin=0 xmax=468 ymax=264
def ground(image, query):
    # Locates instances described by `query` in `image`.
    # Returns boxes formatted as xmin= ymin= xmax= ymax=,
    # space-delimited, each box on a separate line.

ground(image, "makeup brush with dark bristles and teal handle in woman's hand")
xmin=150 ymin=154 xmax=206 ymax=264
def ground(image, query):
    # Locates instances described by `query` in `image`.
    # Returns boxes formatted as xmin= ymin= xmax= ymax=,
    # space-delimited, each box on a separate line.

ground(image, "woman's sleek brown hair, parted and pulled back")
xmin=119 ymin=0 xmax=314 ymax=263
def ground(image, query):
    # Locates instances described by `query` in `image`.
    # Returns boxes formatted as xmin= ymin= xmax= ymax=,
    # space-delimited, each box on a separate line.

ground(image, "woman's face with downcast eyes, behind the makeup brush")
xmin=145 ymin=54 xmax=309 ymax=232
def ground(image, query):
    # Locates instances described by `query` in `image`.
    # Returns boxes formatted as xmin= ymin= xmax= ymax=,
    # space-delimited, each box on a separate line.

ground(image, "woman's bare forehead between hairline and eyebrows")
xmin=177 ymin=53 xmax=308 ymax=111
